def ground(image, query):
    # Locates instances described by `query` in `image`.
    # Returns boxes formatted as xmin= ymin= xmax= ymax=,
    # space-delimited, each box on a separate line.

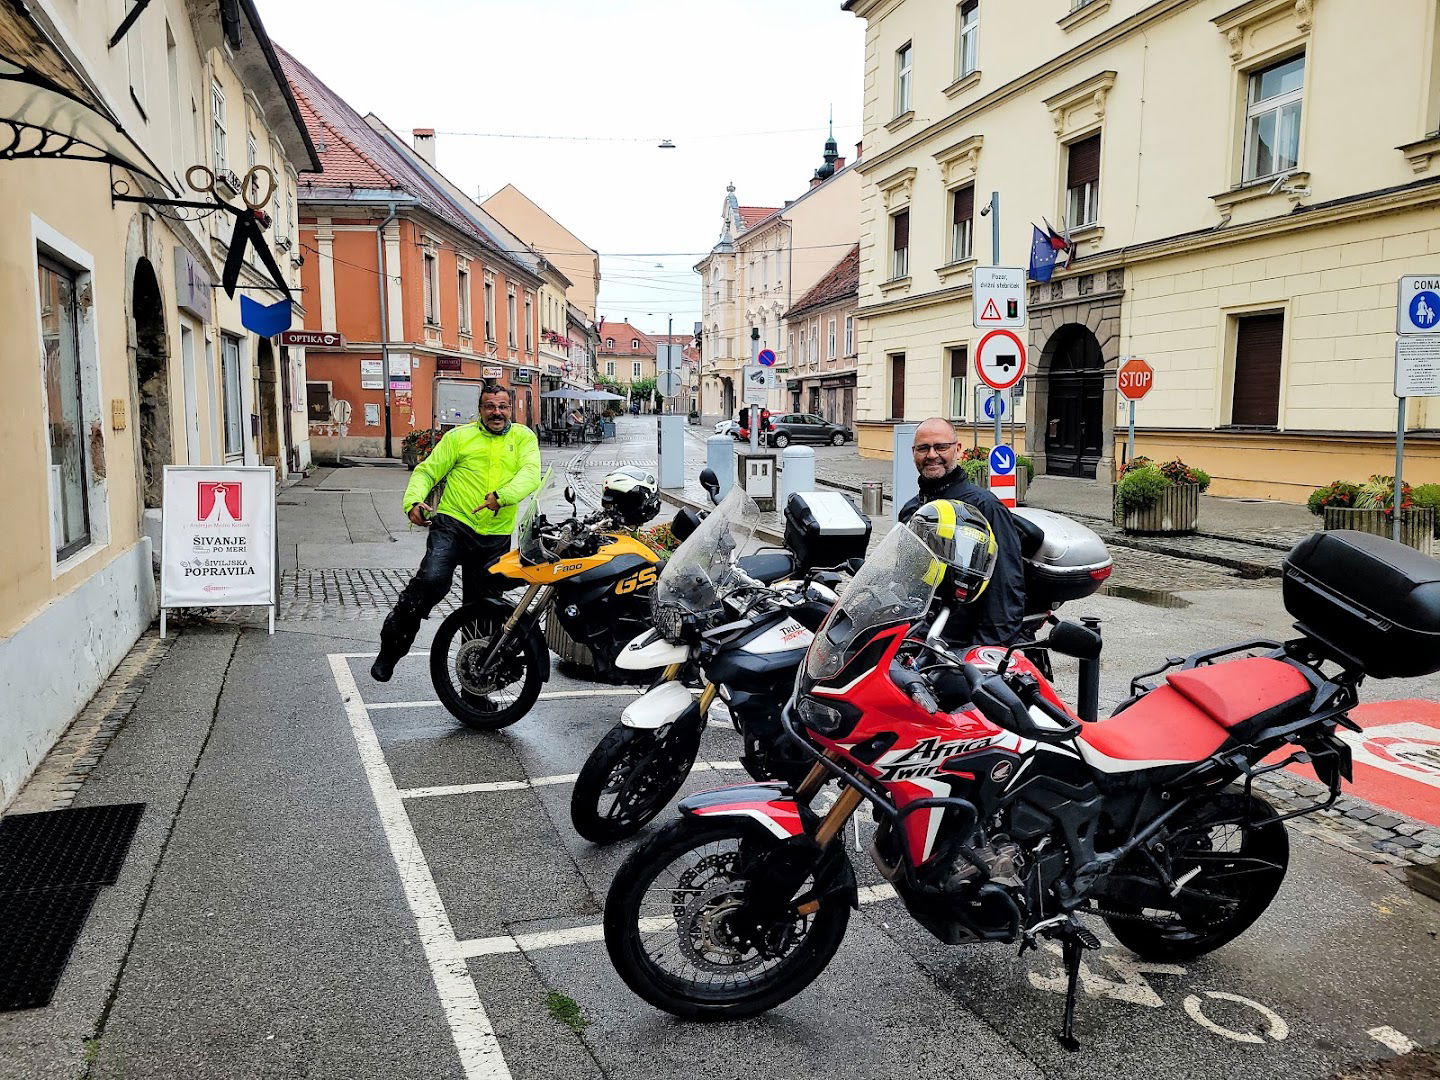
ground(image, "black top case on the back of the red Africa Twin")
xmin=1283 ymin=528 xmax=1440 ymax=678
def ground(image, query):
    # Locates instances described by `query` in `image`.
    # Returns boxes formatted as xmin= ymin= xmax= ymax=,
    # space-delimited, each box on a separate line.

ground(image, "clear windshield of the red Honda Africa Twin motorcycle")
xmin=805 ymin=526 xmax=945 ymax=681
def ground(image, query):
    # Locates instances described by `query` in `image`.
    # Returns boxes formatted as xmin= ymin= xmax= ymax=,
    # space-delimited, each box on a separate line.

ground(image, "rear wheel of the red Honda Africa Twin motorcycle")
xmin=1102 ymin=792 xmax=1290 ymax=960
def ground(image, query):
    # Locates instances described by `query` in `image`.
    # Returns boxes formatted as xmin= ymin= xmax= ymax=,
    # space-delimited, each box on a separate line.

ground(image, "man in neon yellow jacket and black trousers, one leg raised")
xmin=370 ymin=383 xmax=540 ymax=683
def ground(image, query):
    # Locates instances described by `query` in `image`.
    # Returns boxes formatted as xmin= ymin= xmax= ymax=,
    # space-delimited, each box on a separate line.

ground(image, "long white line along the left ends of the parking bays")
xmin=328 ymin=655 xmax=510 ymax=1080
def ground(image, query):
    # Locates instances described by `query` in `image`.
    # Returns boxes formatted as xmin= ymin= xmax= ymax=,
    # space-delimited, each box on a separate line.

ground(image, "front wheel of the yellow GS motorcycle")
xmin=431 ymin=606 xmax=550 ymax=732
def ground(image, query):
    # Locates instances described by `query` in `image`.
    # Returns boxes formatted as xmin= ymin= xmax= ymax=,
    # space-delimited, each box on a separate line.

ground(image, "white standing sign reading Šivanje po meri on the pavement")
xmin=160 ymin=465 xmax=276 ymax=636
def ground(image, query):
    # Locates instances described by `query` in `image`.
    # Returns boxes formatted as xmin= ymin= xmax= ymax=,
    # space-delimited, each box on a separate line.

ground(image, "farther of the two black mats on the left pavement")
xmin=0 ymin=802 xmax=145 ymax=894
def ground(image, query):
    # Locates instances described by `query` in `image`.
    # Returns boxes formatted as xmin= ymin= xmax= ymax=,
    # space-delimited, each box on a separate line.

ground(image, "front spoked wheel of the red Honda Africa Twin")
xmin=605 ymin=818 xmax=850 ymax=1020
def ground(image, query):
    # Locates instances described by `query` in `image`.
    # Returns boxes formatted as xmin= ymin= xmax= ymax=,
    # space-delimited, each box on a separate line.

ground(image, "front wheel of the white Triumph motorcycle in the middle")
xmin=570 ymin=713 xmax=700 ymax=844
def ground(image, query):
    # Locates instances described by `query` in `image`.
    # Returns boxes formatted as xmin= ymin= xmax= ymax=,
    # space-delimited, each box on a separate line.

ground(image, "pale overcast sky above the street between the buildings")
xmin=256 ymin=0 xmax=864 ymax=333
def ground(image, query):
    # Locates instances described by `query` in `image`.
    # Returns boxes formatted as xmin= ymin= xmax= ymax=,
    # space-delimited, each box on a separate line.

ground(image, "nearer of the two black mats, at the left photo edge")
xmin=0 ymin=886 xmax=101 ymax=1012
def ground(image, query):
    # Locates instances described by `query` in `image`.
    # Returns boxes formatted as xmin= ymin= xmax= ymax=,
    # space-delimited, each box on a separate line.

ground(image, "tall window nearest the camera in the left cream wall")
xmin=39 ymin=256 xmax=91 ymax=560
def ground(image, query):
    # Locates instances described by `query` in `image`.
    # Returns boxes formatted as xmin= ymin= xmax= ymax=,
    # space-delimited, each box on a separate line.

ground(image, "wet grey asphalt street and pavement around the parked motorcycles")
xmin=0 ymin=418 xmax=1440 ymax=1080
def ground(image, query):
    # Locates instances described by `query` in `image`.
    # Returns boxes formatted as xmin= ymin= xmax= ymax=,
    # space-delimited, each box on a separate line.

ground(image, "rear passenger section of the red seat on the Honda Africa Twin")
xmin=1079 ymin=687 xmax=1228 ymax=772
